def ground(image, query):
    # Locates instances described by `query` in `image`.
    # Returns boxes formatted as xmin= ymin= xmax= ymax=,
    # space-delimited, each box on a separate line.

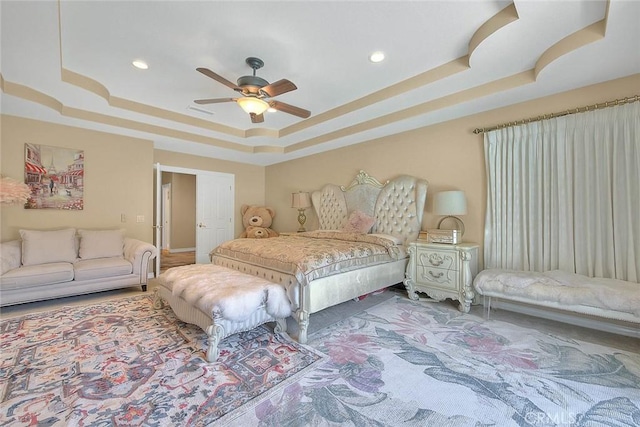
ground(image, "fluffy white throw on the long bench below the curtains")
xmin=473 ymin=269 xmax=640 ymax=318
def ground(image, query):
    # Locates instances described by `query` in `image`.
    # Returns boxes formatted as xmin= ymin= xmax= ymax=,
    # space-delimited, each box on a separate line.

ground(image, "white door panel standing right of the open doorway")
xmin=196 ymin=173 xmax=234 ymax=264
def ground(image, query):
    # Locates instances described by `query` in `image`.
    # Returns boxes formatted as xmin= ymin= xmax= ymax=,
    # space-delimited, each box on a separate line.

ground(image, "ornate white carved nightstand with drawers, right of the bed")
xmin=404 ymin=240 xmax=478 ymax=313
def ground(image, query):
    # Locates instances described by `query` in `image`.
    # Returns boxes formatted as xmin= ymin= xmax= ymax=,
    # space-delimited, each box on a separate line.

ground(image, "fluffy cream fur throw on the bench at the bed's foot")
xmin=158 ymin=264 xmax=291 ymax=321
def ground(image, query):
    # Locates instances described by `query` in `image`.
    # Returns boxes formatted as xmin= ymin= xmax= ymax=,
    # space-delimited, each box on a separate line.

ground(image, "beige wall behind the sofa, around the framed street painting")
xmin=0 ymin=115 xmax=153 ymax=242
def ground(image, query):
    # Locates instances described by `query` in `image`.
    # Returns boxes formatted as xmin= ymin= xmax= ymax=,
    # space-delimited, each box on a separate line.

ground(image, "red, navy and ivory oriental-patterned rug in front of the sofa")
xmin=0 ymin=296 xmax=324 ymax=426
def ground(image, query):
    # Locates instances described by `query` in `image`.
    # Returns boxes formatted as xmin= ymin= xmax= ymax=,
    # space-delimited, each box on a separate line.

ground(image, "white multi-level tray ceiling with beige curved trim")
xmin=0 ymin=0 xmax=640 ymax=165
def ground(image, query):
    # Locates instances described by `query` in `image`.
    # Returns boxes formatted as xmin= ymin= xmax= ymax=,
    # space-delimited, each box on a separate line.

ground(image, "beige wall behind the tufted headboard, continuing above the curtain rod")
xmin=266 ymin=74 xmax=640 ymax=268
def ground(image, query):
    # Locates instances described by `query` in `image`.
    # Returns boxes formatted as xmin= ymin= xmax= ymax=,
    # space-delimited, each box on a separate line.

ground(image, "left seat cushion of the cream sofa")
xmin=0 ymin=262 xmax=73 ymax=290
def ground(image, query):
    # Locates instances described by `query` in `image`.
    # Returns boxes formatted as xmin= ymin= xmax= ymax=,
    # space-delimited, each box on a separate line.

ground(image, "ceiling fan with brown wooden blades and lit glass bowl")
xmin=193 ymin=57 xmax=311 ymax=123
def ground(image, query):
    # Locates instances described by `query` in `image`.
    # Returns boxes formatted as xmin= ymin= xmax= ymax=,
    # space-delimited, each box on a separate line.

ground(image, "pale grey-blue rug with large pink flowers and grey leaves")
xmin=221 ymin=297 xmax=640 ymax=427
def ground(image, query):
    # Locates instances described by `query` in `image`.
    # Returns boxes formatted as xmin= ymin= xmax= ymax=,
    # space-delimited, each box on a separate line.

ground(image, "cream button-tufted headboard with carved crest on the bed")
xmin=311 ymin=171 xmax=429 ymax=242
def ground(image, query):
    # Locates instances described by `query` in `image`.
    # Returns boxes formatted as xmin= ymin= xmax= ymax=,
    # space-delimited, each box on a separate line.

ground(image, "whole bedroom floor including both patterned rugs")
xmin=0 ymin=284 xmax=640 ymax=426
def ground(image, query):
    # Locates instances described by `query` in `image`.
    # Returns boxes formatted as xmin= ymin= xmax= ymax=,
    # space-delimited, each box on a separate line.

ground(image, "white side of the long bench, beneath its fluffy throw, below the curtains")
xmin=478 ymin=298 xmax=640 ymax=338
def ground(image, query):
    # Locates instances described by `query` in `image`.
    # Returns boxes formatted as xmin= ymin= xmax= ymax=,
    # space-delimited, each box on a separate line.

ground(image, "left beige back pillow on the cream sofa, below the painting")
xmin=20 ymin=228 xmax=78 ymax=265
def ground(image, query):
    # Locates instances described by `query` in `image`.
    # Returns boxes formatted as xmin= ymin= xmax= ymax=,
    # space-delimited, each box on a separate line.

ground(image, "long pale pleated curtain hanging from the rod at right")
xmin=484 ymin=102 xmax=640 ymax=282
